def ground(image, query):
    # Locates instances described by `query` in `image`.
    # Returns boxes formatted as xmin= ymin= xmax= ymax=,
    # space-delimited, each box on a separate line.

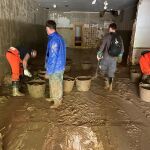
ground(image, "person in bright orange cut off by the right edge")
xmin=139 ymin=51 xmax=150 ymax=79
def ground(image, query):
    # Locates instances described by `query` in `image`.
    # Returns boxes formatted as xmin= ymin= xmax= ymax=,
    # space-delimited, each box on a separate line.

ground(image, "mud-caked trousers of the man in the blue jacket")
xmin=49 ymin=71 xmax=64 ymax=102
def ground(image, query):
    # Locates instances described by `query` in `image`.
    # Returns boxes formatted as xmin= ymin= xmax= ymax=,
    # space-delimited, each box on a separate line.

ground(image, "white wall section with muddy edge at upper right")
xmin=130 ymin=0 xmax=150 ymax=65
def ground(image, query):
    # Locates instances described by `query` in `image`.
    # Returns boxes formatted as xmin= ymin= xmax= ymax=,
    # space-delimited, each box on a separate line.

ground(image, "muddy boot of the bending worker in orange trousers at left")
xmin=12 ymin=81 xmax=24 ymax=96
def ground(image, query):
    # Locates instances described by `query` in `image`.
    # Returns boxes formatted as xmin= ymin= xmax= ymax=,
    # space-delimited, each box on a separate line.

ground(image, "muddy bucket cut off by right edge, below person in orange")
xmin=139 ymin=83 xmax=150 ymax=102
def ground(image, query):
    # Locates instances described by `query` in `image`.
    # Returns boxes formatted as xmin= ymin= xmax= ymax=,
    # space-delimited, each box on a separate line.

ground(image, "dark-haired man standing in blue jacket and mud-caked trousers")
xmin=45 ymin=20 xmax=66 ymax=108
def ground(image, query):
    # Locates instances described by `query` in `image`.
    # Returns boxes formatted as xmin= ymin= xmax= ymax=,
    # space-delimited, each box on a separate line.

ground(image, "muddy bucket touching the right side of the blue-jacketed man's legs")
xmin=64 ymin=77 xmax=75 ymax=93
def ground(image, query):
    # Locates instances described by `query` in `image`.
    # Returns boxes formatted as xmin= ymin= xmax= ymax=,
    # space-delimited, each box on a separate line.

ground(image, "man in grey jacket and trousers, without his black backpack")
xmin=97 ymin=23 xmax=124 ymax=91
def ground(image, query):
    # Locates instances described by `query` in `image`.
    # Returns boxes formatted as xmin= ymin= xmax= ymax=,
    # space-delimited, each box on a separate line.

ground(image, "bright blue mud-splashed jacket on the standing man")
xmin=45 ymin=32 xmax=66 ymax=75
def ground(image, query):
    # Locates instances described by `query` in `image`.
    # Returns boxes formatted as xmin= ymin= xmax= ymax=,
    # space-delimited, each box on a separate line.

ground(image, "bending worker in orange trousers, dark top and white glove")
xmin=6 ymin=47 xmax=37 ymax=96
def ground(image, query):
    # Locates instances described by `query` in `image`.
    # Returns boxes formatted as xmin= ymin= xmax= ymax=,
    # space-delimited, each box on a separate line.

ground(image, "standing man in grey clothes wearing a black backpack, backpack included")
xmin=97 ymin=23 xmax=124 ymax=91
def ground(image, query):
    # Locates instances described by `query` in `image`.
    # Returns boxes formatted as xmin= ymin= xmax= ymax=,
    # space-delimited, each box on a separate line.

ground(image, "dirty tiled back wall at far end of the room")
xmin=48 ymin=6 xmax=136 ymax=64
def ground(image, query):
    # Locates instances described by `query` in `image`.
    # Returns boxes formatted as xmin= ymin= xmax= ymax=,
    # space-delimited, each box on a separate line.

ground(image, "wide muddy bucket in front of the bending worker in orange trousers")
xmin=27 ymin=79 xmax=46 ymax=98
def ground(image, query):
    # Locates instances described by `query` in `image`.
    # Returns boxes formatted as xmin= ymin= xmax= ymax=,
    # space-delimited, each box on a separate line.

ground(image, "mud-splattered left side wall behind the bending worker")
xmin=0 ymin=0 xmax=47 ymax=82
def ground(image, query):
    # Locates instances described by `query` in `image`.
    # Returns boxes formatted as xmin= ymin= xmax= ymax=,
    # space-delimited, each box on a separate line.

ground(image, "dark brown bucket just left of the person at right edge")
xmin=130 ymin=69 xmax=141 ymax=83
